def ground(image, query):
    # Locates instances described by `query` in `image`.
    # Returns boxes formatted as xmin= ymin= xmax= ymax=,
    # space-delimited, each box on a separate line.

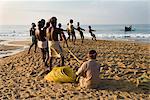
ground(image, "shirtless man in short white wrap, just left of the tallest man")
xmin=36 ymin=19 xmax=49 ymax=66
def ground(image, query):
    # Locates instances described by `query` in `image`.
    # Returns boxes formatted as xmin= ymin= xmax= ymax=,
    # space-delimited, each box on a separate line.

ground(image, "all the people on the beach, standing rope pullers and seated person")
xmin=28 ymin=17 xmax=99 ymax=88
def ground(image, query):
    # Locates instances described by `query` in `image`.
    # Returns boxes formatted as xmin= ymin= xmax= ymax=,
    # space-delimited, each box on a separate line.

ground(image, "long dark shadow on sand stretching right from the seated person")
xmin=98 ymin=79 xmax=150 ymax=94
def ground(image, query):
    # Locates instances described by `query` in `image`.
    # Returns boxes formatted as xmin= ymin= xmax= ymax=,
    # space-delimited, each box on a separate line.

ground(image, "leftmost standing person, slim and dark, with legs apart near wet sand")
xmin=28 ymin=23 xmax=37 ymax=54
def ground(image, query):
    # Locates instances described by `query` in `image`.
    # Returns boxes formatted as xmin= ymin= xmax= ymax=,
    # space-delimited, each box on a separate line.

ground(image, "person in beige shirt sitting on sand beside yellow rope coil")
xmin=76 ymin=50 xmax=100 ymax=88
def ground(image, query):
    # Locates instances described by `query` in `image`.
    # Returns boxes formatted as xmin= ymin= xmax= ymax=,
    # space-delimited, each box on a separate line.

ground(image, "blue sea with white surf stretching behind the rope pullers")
xmin=0 ymin=24 xmax=150 ymax=43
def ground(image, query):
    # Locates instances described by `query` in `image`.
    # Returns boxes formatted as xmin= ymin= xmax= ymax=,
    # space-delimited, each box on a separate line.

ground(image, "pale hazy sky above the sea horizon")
xmin=0 ymin=0 xmax=150 ymax=25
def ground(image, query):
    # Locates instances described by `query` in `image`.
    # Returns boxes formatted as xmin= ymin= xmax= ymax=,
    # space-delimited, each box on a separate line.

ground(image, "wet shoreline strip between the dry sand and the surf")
xmin=0 ymin=38 xmax=150 ymax=58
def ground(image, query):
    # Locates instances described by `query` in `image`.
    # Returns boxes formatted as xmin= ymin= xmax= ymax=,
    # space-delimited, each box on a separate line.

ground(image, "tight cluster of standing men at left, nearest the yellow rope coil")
xmin=28 ymin=17 xmax=65 ymax=71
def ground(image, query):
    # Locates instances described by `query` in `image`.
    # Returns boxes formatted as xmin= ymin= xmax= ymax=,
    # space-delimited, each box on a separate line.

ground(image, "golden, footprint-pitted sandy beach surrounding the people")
xmin=0 ymin=40 xmax=150 ymax=100
